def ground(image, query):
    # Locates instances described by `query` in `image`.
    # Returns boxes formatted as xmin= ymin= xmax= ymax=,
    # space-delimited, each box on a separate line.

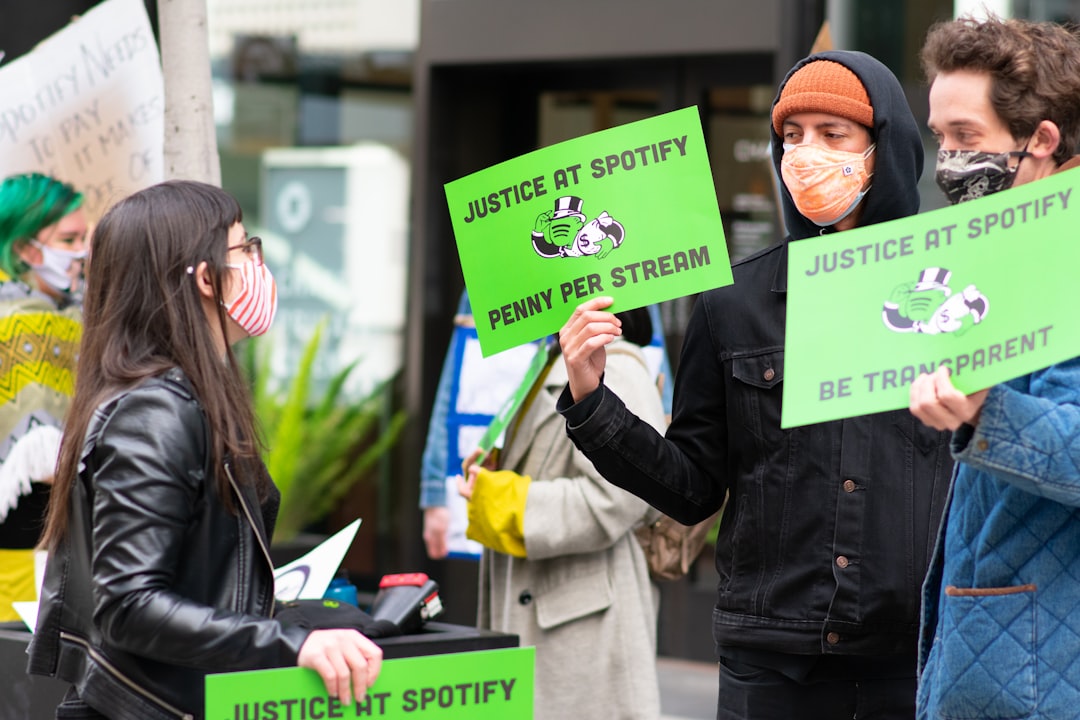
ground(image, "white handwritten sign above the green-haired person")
xmin=0 ymin=0 xmax=165 ymax=219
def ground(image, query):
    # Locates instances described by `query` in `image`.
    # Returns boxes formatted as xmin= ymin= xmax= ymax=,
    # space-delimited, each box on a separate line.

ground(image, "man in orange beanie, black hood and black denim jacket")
xmin=558 ymin=52 xmax=953 ymax=720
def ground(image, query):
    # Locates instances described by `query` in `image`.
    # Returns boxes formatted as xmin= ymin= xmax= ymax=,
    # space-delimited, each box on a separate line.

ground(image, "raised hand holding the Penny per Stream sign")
xmin=558 ymin=297 xmax=622 ymax=403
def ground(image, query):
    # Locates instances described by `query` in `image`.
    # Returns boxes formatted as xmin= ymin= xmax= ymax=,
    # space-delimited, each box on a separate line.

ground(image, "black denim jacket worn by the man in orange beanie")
xmin=559 ymin=241 xmax=953 ymax=660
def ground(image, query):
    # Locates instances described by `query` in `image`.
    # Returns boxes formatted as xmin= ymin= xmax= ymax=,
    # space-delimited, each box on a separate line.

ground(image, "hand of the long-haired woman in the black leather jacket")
xmin=296 ymin=628 xmax=382 ymax=705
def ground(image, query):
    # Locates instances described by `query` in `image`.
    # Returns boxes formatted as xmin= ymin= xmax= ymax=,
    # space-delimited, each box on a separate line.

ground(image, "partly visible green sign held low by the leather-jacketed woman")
xmin=206 ymin=648 xmax=536 ymax=720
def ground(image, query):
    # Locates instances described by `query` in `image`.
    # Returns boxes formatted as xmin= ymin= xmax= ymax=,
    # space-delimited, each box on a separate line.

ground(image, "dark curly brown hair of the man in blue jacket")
xmin=920 ymin=17 xmax=1080 ymax=165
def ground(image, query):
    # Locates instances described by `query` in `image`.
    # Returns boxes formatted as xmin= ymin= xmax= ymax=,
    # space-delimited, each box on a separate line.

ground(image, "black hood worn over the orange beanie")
xmin=769 ymin=50 xmax=923 ymax=240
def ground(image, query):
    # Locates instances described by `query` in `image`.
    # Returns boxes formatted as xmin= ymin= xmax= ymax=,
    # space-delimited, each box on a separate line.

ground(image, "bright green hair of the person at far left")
xmin=0 ymin=173 xmax=82 ymax=277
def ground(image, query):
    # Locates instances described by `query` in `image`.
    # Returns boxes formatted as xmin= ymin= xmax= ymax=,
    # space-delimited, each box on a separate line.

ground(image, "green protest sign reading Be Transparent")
xmin=781 ymin=171 xmax=1080 ymax=427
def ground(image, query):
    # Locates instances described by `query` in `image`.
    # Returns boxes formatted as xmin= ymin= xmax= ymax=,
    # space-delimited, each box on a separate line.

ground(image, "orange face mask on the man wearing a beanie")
xmin=780 ymin=144 xmax=877 ymax=228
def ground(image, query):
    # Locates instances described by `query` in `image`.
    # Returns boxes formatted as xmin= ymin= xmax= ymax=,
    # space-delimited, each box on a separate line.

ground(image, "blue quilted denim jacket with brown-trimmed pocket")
xmin=918 ymin=358 xmax=1080 ymax=720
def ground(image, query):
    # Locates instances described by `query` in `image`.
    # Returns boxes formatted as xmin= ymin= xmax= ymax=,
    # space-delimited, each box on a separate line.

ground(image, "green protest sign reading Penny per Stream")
xmin=445 ymin=107 xmax=731 ymax=356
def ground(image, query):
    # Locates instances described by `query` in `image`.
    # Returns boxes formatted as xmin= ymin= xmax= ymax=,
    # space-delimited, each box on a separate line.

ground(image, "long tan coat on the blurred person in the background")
xmin=478 ymin=340 xmax=664 ymax=720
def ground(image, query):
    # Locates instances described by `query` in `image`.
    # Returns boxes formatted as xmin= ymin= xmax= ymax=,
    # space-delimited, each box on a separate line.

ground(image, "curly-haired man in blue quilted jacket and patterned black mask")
xmin=912 ymin=18 xmax=1080 ymax=719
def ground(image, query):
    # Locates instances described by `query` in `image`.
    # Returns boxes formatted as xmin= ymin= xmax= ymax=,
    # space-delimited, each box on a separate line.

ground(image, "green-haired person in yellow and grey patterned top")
xmin=0 ymin=173 xmax=90 ymax=622
